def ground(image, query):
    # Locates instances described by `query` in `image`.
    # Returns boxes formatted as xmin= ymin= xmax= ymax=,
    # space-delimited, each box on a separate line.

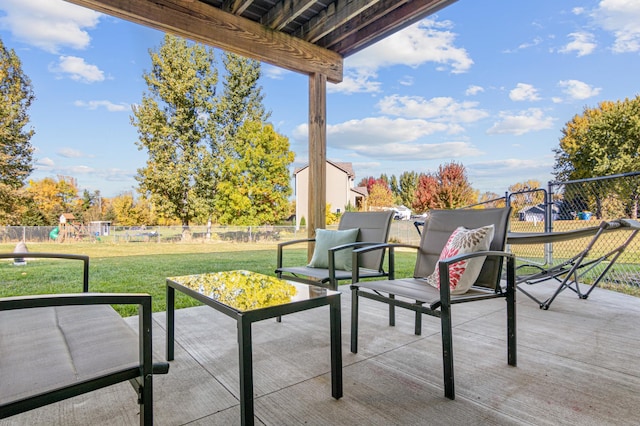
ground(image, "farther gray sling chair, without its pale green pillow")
xmin=275 ymin=211 xmax=394 ymax=290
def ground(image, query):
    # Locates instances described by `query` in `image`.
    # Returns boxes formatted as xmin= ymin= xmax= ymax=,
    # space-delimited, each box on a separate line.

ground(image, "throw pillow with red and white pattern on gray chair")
xmin=427 ymin=225 xmax=494 ymax=295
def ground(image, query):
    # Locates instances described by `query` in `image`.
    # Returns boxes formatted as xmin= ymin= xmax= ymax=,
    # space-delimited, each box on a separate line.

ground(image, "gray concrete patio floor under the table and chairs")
xmin=0 ymin=284 xmax=640 ymax=426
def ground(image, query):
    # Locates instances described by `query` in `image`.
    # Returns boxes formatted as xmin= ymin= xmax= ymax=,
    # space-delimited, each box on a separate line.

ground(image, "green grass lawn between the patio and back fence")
xmin=0 ymin=243 xmax=415 ymax=316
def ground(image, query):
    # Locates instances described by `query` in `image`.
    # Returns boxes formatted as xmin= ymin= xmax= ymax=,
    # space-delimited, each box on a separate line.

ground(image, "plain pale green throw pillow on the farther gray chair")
xmin=307 ymin=228 xmax=360 ymax=271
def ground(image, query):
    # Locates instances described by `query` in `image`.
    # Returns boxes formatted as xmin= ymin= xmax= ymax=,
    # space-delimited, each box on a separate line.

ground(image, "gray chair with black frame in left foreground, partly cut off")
xmin=0 ymin=253 xmax=169 ymax=426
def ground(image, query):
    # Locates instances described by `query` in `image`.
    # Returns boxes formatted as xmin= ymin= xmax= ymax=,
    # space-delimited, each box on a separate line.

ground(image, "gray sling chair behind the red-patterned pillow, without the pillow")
xmin=351 ymin=208 xmax=516 ymax=399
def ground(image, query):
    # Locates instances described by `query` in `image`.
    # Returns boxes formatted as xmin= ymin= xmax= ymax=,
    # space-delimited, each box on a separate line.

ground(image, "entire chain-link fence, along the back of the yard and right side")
xmin=0 ymin=172 xmax=640 ymax=286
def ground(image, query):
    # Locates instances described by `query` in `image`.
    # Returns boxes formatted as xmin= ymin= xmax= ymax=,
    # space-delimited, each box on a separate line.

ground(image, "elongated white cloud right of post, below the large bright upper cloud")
xmin=378 ymin=95 xmax=489 ymax=123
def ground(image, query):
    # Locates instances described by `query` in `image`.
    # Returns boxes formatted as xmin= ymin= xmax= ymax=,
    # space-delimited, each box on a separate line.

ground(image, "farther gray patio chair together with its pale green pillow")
xmin=275 ymin=211 xmax=394 ymax=290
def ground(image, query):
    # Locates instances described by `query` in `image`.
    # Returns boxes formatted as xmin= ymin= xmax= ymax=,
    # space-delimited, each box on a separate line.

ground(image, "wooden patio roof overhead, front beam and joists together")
xmin=67 ymin=0 xmax=456 ymax=82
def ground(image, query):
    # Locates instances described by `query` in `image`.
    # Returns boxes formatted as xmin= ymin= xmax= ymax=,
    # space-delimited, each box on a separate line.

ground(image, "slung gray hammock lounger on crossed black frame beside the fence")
xmin=507 ymin=219 xmax=640 ymax=310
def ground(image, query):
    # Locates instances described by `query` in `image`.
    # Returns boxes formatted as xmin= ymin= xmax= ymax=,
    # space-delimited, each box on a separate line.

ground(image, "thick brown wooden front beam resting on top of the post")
xmin=67 ymin=0 xmax=343 ymax=83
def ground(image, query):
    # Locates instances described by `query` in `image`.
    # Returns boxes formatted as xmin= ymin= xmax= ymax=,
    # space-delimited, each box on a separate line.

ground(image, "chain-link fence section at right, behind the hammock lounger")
xmin=507 ymin=172 xmax=640 ymax=286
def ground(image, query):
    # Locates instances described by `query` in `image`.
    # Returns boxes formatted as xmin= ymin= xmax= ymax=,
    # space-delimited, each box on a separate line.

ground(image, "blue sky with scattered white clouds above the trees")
xmin=0 ymin=0 xmax=640 ymax=197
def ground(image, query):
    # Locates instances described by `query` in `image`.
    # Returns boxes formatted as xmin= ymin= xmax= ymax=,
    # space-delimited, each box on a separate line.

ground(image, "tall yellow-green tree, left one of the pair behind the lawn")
xmin=131 ymin=35 xmax=218 ymax=232
